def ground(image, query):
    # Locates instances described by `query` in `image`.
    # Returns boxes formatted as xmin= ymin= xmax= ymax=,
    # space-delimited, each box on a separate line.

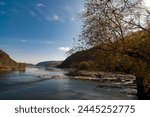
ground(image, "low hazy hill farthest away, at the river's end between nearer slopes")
xmin=36 ymin=61 xmax=62 ymax=67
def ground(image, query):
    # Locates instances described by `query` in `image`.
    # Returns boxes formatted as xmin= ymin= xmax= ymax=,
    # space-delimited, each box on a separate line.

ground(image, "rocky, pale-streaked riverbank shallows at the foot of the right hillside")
xmin=67 ymin=70 xmax=137 ymax=95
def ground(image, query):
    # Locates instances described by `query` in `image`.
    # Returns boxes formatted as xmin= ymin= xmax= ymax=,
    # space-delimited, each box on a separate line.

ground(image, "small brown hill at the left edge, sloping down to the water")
xmin=0 ymin=49 xmax=25 ymax=71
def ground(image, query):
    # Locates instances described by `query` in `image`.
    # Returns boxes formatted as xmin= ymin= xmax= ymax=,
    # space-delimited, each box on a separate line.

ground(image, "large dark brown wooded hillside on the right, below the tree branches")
xmin=60 ymin=31 xmax=150 ymax=74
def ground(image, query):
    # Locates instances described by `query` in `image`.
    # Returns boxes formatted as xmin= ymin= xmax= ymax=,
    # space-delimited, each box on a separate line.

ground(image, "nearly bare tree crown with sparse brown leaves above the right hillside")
xmin=76 ymin=0 xmax=150 ymax=50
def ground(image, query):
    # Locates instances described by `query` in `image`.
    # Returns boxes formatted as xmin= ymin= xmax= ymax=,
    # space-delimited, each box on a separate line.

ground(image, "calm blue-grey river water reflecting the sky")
xmin=0 ymin=68 xmax=136 ymax=100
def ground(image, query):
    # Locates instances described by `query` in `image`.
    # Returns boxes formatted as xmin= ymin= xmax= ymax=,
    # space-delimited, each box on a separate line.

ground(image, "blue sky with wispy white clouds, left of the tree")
xmin=0 ymin=0 xmax=83 ymax=63
